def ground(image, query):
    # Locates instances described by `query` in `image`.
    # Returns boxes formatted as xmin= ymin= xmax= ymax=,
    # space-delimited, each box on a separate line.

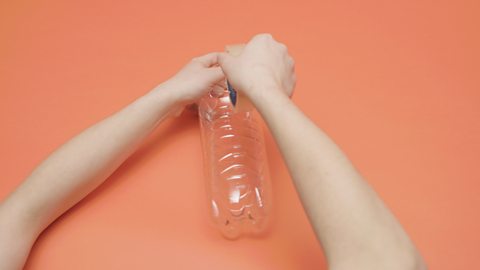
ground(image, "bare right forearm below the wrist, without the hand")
xmin=252 ymin=91 xmax=424 ymax=269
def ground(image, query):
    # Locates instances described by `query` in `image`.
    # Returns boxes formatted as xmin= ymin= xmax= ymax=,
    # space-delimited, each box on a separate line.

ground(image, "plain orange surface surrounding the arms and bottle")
xmin=0 ymin=0 xmax=480 ymax=270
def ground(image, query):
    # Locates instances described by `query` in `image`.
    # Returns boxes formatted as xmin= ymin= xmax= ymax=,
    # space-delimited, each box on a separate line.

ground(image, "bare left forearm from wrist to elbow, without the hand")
xmin=2 ymin=84 xmax=174 ymax=235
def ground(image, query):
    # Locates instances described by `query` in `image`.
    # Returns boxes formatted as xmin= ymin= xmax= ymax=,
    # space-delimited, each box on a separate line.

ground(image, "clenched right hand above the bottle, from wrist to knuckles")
xmin=218 ymin=34 xmax=296 ymax=101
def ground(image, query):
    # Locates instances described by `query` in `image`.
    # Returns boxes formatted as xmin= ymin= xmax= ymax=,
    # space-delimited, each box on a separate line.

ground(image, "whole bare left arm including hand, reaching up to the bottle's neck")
xmin=0 ymin=53 xmax=223 ymax=269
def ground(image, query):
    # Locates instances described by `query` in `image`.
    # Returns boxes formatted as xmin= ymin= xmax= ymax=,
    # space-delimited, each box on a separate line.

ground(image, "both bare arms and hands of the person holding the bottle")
xmin=0 ymin=34 xmax=426 ymax=270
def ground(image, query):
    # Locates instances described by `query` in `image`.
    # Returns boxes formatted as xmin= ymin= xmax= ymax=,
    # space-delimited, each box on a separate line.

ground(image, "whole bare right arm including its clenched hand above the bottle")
xmin=220 ymin=35 xmax=424 ymax=270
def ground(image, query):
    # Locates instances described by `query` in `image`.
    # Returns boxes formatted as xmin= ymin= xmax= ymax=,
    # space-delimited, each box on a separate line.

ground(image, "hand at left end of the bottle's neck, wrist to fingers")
xmin=160 ymin=52 xmax=224 ymax=108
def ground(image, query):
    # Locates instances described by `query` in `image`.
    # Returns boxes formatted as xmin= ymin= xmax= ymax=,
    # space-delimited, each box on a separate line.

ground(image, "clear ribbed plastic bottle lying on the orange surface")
xmin=198 ymin=45 xmax=271 ymax=239
